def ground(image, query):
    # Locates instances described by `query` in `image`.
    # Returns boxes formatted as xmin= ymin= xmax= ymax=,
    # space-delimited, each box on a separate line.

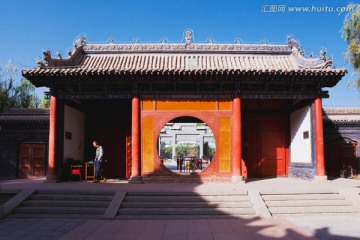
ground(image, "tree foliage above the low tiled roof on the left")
xmin=0 ymin=61 xmax=42 ymax=112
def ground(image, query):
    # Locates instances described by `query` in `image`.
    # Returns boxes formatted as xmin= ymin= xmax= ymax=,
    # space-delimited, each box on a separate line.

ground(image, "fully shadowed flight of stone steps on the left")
xmin=8 ymin=190 xmax=115 ymax=219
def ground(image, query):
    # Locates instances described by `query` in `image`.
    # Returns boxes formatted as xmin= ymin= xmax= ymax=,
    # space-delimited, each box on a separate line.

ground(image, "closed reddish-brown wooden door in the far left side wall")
xmin=19 ymin=143 xmax=46 ymax=178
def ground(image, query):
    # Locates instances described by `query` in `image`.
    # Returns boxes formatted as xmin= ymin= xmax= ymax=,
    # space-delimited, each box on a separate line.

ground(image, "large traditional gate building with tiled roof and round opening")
xmin=22 ymin=31 xmax=346 ymax=182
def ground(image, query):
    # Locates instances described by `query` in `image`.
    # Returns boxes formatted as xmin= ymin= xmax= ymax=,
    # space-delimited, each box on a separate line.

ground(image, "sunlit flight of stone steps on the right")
xmin=260 ymin=190 xmax=360 ymax=217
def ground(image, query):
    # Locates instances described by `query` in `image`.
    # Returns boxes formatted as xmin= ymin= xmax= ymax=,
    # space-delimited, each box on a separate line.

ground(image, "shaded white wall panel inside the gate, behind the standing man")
xmin=64 ymin=105 xmax=85 ymax=161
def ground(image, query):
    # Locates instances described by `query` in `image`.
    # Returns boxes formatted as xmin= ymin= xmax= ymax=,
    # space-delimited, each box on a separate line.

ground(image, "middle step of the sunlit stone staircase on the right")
xmin=265 ymin=200 xmax=352 ymax=207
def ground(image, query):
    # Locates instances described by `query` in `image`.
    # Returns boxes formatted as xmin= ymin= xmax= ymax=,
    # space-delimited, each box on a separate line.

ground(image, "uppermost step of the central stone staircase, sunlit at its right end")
xmin=124 ymin=195 xmax=250 ymax=202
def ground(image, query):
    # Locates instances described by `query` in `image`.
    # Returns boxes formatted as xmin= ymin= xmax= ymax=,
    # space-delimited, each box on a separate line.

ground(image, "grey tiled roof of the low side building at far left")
xmin=0 ymin=108 xmax=50 ymax=123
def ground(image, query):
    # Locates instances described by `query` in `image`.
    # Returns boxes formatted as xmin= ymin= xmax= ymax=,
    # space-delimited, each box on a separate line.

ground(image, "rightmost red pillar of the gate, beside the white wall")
xmin=314 ymin=97 xmax=326 ymax=177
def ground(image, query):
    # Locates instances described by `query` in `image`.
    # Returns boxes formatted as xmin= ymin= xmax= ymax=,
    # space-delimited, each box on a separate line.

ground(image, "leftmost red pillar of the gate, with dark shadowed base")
xmin=45 ymin=96 xmax=58 ymax=182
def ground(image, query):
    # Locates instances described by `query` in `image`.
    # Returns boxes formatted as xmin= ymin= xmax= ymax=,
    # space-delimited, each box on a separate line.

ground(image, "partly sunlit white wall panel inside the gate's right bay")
xmin=290 ymin=106 xmax=312 ymax=163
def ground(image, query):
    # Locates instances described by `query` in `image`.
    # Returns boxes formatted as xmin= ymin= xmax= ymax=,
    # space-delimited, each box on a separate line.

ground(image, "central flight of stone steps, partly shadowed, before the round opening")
xmin=116 ymin=191 xmax=256 ymax=219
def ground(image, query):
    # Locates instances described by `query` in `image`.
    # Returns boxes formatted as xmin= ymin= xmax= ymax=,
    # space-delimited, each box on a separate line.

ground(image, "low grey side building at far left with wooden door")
xmin=0 ymin=108 xmax=50 ymax=179
